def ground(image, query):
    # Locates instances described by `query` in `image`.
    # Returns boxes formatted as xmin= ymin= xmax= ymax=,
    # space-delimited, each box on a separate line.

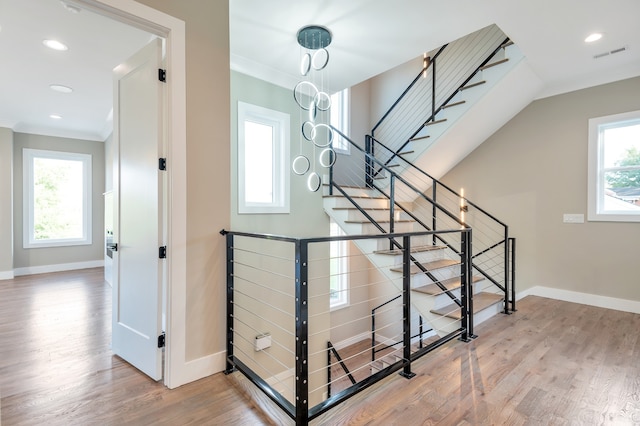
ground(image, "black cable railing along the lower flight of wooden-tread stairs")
xmin=330 ymin=128 xmax=515 ymax=314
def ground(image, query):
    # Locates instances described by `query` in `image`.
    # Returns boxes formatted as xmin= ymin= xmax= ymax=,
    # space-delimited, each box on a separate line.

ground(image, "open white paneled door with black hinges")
xmin=112 ymin=39 xmax=165 ymax=380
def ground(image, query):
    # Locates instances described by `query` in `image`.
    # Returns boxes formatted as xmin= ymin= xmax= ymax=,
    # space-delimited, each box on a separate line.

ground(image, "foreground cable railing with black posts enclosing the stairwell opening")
xmin=221 ymin=227 xmax=473 ymax=425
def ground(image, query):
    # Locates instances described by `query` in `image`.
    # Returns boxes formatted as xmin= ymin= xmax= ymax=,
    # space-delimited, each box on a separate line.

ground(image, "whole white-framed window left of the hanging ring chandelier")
xmin=238 ymin=102 xmax=289 ymax=213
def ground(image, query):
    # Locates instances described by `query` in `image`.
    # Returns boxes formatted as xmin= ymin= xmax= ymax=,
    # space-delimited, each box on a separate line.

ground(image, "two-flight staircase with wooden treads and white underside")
xmin=324 ymin=26 xmax=524 ymax=346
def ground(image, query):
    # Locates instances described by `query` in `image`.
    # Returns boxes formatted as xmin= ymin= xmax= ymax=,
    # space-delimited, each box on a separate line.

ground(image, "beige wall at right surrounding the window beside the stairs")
xmin=443 ymin=77 xmax=640 ymax=301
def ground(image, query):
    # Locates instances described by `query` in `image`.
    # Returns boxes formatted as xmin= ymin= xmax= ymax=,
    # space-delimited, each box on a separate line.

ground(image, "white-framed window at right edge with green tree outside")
xmin=588 ymin=111 xmax=640 ymax=222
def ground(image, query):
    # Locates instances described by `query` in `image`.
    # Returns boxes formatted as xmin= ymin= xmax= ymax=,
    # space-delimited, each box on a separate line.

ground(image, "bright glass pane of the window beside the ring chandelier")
xmin=244 ymin=121 xmax=274 ymax=203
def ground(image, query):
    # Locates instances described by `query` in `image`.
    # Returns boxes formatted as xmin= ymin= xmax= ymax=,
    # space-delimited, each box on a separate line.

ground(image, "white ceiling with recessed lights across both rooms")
xmin=0 ymin=0 xmax=640 ymax=140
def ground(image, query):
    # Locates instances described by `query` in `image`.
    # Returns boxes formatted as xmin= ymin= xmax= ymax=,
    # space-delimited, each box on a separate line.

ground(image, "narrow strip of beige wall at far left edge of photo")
xmin=0 ymin=128 xmax=13 ymax=279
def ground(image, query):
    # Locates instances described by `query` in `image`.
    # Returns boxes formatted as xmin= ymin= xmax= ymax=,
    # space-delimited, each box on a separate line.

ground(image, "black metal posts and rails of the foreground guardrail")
xmin=220 ymin=228 xmax=473 ymax=425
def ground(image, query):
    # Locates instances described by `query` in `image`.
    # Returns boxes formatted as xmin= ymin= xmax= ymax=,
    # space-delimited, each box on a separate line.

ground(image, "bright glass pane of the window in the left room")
xmin=33 ymin=158 xmax=84 ymax=241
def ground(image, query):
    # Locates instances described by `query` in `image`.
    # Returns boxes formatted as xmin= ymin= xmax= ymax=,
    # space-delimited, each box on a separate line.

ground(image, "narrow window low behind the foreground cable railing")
xmin=329 ymin=220 xmax=349 ymax=310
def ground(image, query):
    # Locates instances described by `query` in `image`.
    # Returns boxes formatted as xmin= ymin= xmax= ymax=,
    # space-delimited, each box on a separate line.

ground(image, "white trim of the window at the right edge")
xmin=587 ymin=111 xmax=640 ymax=222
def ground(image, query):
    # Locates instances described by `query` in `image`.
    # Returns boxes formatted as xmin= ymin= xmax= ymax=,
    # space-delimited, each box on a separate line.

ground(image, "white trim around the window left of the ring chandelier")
xmin=238 ymin=102 xmax=290 ymax=214
